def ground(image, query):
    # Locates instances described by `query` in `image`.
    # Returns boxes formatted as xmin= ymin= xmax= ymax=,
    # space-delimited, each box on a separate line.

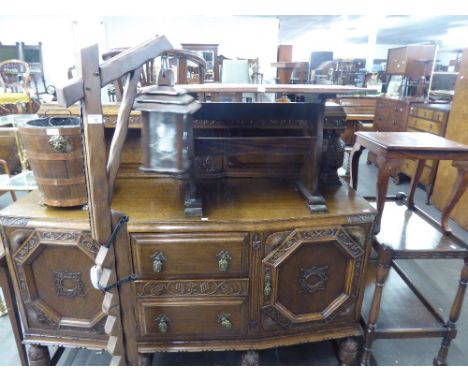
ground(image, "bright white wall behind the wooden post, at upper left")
xmin=0 ymin=16 xmax=278 ymax=89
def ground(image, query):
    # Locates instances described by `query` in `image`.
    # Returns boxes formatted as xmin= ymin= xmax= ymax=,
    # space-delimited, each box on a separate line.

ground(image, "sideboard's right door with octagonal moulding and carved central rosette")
xmin=262 ymin=228 xmax=365 ymax=330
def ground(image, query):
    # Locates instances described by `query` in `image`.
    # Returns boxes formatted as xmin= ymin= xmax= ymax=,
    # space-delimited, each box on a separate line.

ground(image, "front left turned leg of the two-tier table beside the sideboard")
xmin=361 ymin=246 xmax=392 ymax=366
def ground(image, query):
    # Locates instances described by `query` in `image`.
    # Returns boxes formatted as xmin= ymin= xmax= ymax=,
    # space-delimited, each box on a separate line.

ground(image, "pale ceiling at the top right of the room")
xmin=277 ymin=15 xmax=468 ymax=48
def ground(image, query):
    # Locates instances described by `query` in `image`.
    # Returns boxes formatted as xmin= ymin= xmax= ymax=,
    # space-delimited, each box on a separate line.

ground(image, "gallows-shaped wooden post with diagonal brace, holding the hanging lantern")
xmin=57 ymin=36 xmax=172 ymax=365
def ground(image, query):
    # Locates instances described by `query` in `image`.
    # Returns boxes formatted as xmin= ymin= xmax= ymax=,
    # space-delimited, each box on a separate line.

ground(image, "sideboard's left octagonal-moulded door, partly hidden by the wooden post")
xmin=13 ymin=230 xmax=105 ymax=335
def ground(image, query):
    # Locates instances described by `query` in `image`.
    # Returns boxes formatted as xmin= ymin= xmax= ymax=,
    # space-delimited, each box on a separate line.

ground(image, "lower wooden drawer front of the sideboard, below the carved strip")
xmin=139 ymin=297 xmax=248 ymax=339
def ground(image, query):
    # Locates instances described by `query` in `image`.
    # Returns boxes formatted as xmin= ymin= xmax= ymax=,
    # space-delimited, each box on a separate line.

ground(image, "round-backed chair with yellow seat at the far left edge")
xmin=0 ymin=60 xmax=33 ymax=115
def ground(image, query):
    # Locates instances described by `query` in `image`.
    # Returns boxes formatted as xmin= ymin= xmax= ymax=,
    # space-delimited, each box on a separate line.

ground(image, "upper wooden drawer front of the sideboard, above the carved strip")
xmin=132 ymin=233 xmax=248 ymax=278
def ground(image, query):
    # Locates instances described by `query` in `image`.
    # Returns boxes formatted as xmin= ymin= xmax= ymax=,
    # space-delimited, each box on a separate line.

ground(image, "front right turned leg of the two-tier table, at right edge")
xmin=433 ymin=257 xmax=468 ymax=366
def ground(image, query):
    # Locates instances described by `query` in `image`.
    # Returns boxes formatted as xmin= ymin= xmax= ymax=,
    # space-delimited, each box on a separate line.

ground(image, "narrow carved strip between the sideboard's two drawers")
xmin=135 ymin=280 xmax=249 ymax=297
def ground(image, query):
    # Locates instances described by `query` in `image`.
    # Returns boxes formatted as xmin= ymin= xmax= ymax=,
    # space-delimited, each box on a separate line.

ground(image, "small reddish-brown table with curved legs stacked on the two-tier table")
xmin=350 ymin=132 xmax=468 ymax=233
